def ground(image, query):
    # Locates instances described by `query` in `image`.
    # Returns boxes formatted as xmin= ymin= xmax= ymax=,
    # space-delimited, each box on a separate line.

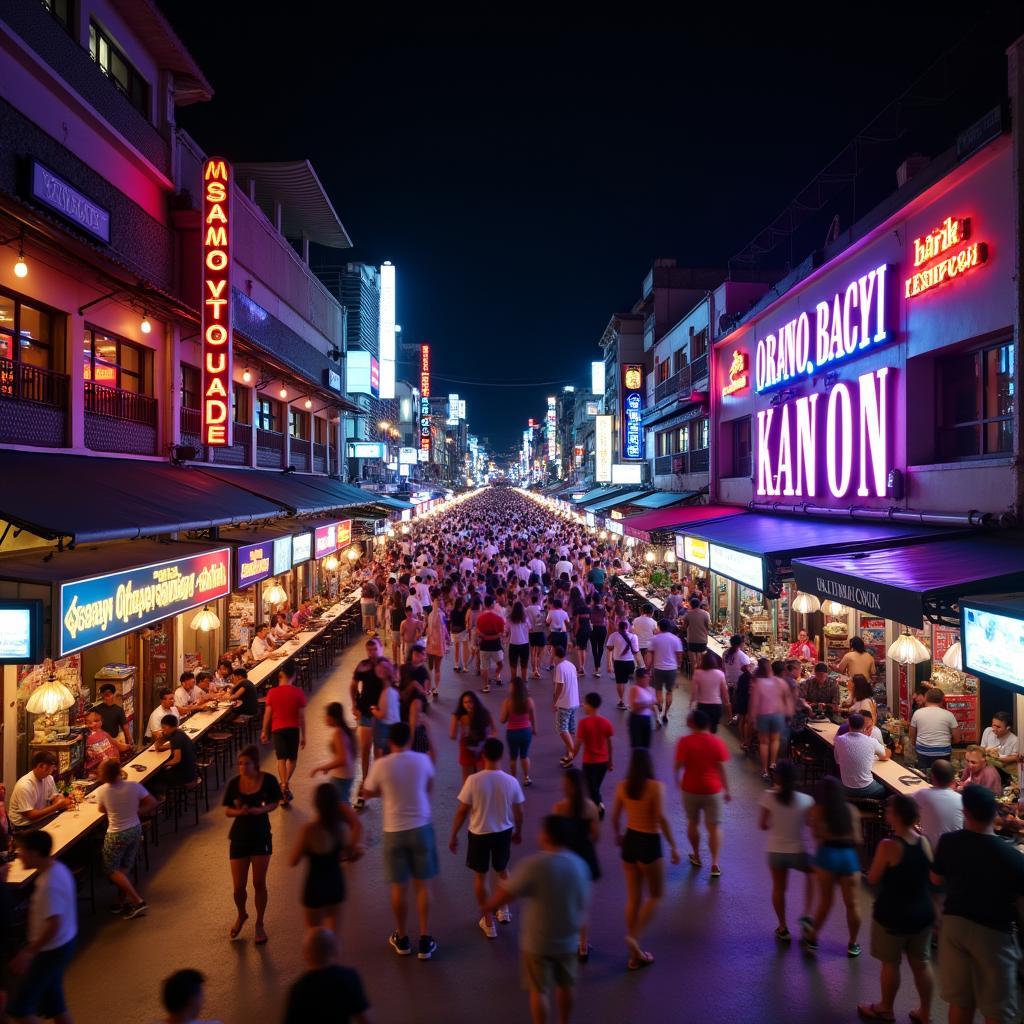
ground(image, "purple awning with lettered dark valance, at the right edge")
xmin=793 ymin=536 xmax=1024 ymax=627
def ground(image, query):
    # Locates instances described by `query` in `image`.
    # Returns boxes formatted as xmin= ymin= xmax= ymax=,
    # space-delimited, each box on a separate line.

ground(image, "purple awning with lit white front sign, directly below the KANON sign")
xmin=680 ymin=512 xmax=962 ymax=598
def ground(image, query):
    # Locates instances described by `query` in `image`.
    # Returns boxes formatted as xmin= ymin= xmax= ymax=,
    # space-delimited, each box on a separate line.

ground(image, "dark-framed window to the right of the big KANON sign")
xmin=938 ymin=342 xmax=1015 ymax=459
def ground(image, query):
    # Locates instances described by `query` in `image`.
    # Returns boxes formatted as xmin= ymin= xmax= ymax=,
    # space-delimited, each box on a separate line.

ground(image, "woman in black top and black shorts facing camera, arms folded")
xmin=223 ymin=746 xmax=281 ymax=946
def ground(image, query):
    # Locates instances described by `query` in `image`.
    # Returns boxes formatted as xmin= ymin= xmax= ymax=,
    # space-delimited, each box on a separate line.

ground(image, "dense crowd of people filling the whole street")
xmin=6 ymin=489 xmax=1024 ymax=1024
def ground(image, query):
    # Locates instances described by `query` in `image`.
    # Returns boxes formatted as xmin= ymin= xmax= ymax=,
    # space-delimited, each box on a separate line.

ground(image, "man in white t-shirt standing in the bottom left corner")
xmin=7 ymin=829 xmax=78 ymax=1024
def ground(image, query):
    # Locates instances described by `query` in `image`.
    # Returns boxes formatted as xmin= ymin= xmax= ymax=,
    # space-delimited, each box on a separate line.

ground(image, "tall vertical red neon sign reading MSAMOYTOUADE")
xmin=202 ymin=158 xmax=232 ymax=447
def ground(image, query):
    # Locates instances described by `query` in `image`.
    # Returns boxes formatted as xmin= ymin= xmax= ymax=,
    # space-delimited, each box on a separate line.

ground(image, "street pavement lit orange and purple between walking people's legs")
xmin=59 ymin=644 xmax=946 ymax=1024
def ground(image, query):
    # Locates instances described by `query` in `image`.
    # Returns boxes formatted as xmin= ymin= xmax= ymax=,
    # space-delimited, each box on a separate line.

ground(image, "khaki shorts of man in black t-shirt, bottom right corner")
xmin=939 ymin=914 xmax=1021 ymax=1024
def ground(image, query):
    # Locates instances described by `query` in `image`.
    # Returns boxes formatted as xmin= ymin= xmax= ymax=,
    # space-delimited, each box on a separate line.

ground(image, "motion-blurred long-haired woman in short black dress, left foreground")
xmin=289 ymin=782 xmax=362 ymax=935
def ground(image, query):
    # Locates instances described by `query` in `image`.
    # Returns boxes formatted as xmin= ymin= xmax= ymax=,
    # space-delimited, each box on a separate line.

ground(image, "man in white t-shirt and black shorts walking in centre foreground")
xmin=449 ymin=736 xmax=526 ymax=939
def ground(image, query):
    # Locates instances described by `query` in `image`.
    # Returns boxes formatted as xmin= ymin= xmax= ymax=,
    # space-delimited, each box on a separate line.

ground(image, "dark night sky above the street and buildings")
xmin=164 ymin=12 xmax=1019 ymax=446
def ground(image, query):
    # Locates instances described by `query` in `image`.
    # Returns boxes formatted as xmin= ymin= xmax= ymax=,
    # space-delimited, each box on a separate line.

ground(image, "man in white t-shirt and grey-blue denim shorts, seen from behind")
xmin=362 ymin=722 xmax=437 ymax=959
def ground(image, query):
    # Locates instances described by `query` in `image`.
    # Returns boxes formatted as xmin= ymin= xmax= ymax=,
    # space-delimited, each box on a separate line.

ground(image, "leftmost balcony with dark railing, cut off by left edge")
xmin=0 ymin=359 xmax=68 ymax=447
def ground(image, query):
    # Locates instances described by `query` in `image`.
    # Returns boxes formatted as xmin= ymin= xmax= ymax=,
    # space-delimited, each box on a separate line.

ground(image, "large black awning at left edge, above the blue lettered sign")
xmin=0 ymin=450 xmax=285 ymax=544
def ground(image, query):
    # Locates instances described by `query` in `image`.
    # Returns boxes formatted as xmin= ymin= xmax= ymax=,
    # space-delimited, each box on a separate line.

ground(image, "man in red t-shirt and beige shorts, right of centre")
xmin=676 ymin=708 xmax=732 ymax=879
